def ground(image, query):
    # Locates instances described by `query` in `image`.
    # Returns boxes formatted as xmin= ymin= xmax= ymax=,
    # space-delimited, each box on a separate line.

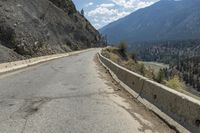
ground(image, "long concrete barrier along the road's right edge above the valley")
xmin=99 ymin=53 xmax=200 ymax=133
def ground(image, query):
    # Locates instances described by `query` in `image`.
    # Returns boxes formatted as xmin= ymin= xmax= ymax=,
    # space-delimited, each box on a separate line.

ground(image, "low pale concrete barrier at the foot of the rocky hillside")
xmin=0 ymin=49 xmax=90 ymax=73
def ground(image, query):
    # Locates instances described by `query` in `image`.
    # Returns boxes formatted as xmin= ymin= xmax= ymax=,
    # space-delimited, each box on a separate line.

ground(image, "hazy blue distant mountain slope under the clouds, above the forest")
xmin=99 ymin=0 xmax=200 ymax=44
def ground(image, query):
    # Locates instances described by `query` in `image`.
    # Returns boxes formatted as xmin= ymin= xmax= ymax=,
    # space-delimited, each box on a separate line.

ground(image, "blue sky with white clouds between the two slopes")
xmin=72 ymin=0 xmax=158 ymax=29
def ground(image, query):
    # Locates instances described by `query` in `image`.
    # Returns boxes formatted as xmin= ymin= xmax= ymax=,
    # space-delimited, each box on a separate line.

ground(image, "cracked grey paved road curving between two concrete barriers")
xmin=0 ymin=50 xmax=173 ymax=133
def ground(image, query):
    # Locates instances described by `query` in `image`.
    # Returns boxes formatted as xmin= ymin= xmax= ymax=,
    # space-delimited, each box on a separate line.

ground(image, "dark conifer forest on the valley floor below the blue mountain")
xmin=136 ymin=40 xmax=200 ymax=91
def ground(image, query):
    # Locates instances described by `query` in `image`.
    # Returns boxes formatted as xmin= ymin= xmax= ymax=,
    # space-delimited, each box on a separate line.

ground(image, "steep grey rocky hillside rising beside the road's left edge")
xmin=0 ymin=0 xmax=101 ymax=62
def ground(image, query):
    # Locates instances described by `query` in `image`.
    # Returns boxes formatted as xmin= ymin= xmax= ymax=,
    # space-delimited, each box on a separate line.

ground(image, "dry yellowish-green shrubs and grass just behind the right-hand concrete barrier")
xmin=102 ymin=43 xmax=185 ymax=90
